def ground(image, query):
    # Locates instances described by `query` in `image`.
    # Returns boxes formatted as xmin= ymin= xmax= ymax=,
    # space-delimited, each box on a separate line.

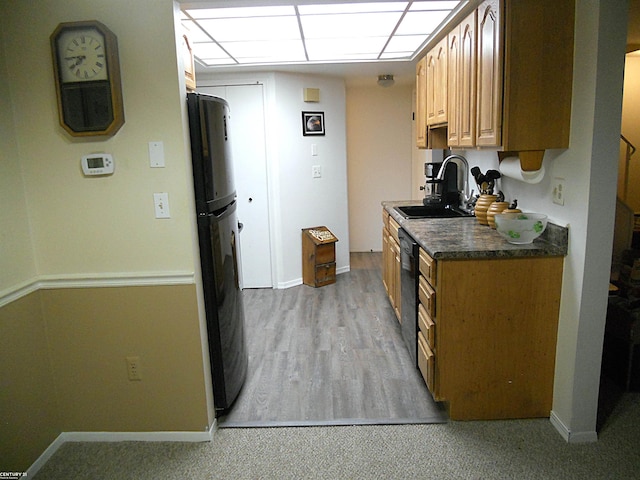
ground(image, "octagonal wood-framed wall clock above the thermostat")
xmin=51 ymin=20 xmax=124 ymax=137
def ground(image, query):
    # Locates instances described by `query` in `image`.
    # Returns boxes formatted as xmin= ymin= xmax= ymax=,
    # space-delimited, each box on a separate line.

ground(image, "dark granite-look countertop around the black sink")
xmin=382 ymin=200 xmax=569 ymax=259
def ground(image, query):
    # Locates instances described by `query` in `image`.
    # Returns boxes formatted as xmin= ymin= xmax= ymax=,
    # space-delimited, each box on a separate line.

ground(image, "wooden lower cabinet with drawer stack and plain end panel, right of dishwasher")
xmin=418 ymin=249 xmax=563 ymax=420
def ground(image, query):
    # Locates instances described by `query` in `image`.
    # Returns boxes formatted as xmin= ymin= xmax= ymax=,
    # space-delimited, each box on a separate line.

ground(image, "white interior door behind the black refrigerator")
xmin=198 ymin=84 xmax=273 ymax=288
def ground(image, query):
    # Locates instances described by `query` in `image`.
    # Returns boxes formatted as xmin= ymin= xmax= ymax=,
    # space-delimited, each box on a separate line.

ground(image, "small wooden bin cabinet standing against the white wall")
xmin=302 ymin=226 xmax=338 ymax=287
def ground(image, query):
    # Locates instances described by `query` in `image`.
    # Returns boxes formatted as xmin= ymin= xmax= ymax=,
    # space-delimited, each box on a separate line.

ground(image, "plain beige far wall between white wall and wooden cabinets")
xmin=347 ymin=85 xmax=413 ymax=252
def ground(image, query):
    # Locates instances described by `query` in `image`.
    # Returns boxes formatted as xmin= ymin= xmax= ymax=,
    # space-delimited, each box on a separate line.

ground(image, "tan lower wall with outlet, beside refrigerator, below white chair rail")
xmin=41 ymin=285 xmax=207 ymax=432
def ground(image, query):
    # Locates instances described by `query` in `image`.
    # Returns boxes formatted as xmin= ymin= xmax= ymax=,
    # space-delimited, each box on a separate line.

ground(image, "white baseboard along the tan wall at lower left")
xmin=26 ymin=426 xmax=218 ymax=478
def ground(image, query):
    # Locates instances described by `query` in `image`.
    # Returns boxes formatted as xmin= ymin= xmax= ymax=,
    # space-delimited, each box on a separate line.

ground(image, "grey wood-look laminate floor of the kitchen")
xmin=218 ymin=253 xmax=447 ymax=428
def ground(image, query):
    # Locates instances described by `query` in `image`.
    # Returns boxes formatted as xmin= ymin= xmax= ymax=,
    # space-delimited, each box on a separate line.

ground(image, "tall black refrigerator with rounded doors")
xmin=187 ymin=93 xmax=248 ymax=417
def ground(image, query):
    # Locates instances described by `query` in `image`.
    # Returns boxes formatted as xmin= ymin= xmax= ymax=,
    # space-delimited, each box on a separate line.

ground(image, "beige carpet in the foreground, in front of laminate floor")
xmin=34 ymin=393 xmax=640 ymax=480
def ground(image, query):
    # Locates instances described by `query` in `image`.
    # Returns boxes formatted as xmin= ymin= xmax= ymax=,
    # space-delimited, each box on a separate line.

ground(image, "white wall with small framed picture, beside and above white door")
xmin=197 ymin=72 xmax=350 ymax=288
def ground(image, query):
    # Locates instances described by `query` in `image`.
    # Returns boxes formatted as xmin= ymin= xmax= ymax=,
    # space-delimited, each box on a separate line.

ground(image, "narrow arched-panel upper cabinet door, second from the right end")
xmin=458 ymin=12 xmax=477 ymax=147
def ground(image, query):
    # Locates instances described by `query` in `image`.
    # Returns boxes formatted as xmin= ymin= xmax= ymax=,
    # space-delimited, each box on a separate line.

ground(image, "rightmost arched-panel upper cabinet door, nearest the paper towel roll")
xmin=476 ymin=0 xmax=502 ymax=146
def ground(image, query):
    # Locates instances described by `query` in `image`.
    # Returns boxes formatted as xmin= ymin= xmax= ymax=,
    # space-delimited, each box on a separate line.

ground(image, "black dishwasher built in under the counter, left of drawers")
xmin=398 ymin=228 xmax=419 ymax=368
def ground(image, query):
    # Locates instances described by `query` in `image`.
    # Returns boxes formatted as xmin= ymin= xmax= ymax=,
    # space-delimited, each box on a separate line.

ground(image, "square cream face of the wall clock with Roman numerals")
xmin=57 ymin=29 xmax=108 ymax=83
